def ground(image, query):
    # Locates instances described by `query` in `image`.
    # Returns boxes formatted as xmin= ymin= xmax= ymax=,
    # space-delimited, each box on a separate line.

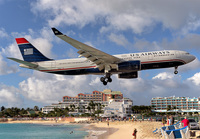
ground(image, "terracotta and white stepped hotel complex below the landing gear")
xmin=42 ymin=89 xmax=133 ymax=117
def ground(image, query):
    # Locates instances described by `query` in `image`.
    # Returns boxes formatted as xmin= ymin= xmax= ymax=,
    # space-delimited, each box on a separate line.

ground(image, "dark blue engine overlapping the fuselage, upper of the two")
xmin=118 ymin=60 xmax=141 ymax=72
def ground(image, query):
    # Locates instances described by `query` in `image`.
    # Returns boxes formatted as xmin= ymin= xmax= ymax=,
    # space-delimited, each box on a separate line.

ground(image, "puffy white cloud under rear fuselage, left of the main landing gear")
xmin=19 ymin=71 xmax=99 ymax=104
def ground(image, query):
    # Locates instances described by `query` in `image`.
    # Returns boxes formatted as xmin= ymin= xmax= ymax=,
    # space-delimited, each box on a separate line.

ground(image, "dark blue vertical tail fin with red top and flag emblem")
xmin=16 ymin=38 xmax=52 ymax=62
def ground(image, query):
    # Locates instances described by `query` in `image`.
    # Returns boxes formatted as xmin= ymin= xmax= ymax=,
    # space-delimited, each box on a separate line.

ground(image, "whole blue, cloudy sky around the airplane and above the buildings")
xmin=0 ymin=0 xmax=200 ymax=108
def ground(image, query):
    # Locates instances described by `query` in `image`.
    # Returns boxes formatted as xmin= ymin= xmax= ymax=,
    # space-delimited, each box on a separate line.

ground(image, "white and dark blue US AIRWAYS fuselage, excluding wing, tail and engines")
xmin=20 ymin=50 xmax=195 ymax=75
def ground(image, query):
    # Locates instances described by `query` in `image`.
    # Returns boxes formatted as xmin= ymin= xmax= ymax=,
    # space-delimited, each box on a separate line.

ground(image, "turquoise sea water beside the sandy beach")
xmin=0 ymin=123 xmax=88 ymax=139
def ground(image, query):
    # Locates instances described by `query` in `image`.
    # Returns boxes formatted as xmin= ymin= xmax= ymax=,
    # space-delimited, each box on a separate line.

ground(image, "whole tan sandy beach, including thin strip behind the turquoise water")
xmin=1 ymin=120 xmax=162 ymax=139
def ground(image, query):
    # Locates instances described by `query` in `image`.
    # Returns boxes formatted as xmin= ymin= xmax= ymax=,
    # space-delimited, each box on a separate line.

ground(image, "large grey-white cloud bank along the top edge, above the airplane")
xmin=31 ymin=0 xmax=200 ymax=34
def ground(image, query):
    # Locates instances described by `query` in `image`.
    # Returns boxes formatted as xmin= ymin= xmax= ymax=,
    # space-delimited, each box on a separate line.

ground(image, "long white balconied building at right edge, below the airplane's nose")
xmin=151 ymin=96 xmax=200 ymax=112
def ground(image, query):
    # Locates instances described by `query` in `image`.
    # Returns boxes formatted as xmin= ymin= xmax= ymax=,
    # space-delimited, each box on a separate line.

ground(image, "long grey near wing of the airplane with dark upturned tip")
xmin=52 ymin=28 xmax=121 ymax=71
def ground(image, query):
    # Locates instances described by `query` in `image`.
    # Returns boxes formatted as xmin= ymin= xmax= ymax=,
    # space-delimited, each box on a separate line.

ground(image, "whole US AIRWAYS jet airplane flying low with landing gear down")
xmin=8 ymin=28 xmax=196 ymax=85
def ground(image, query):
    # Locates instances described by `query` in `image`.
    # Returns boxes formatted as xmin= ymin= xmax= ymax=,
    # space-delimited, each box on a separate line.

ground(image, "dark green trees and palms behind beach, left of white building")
xmin=0 ymin=101 xmax=104 ymax=118
